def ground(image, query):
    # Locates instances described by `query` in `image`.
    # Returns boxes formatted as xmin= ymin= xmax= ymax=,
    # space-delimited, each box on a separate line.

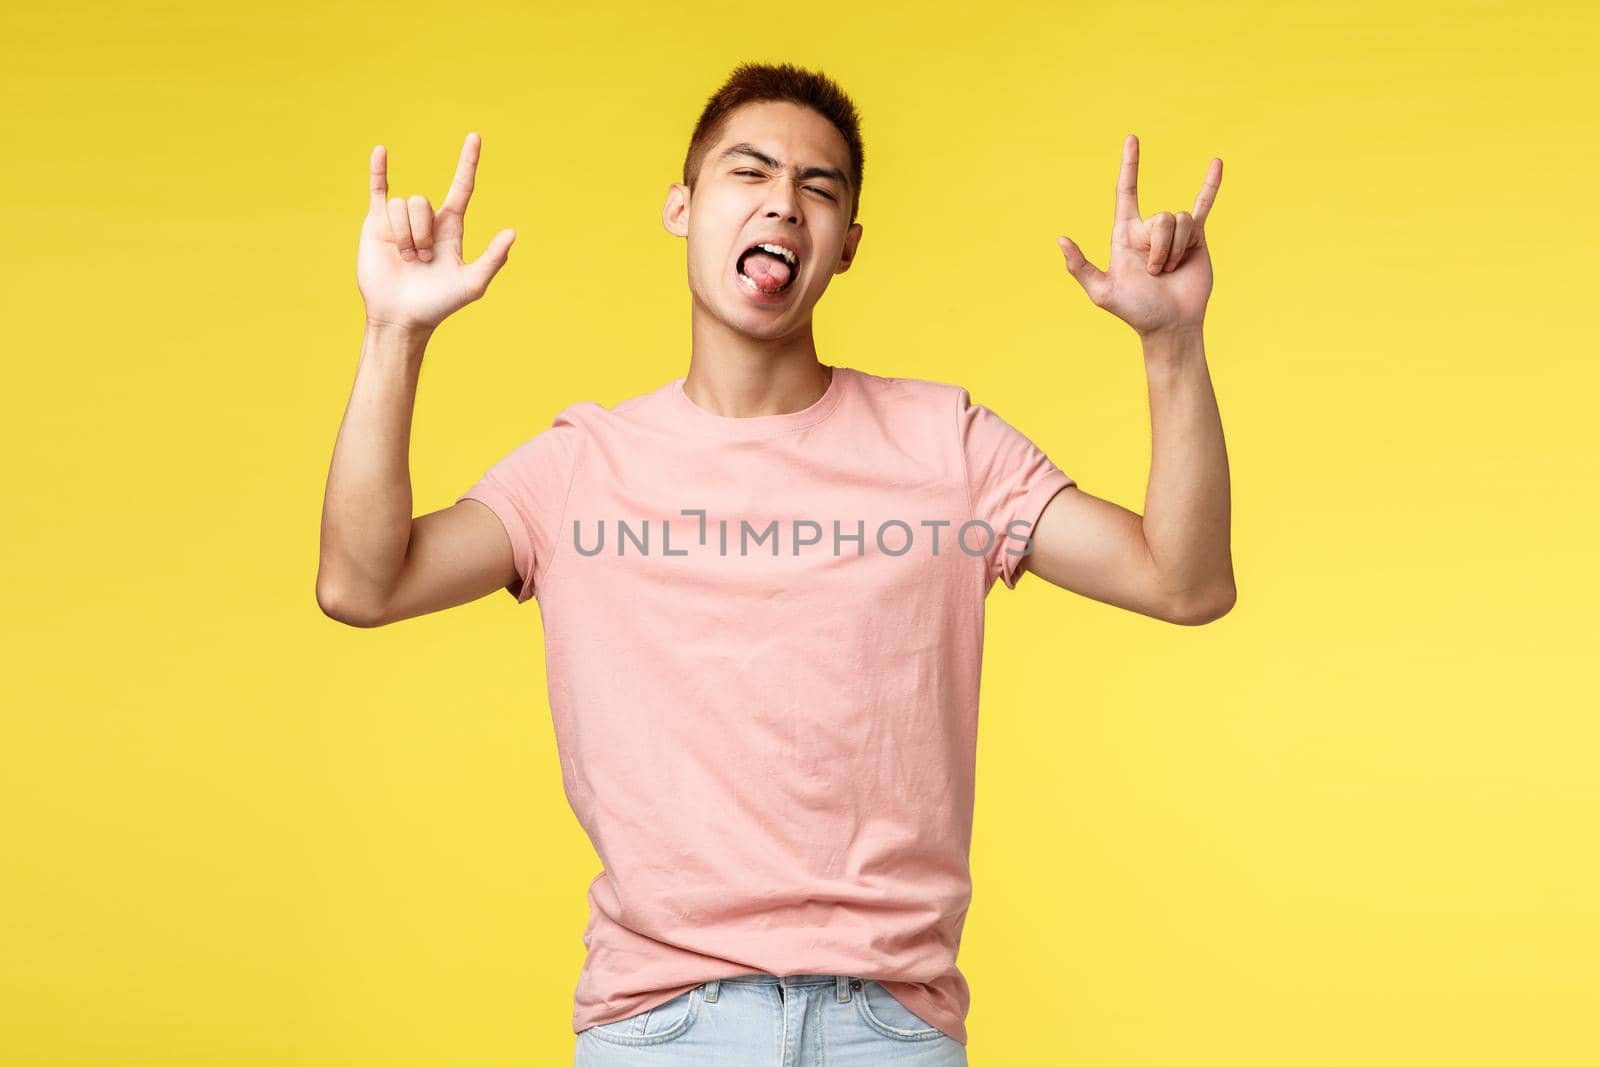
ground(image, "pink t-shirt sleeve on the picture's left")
xmin=456 ymin=410 xmax=581 ymax=603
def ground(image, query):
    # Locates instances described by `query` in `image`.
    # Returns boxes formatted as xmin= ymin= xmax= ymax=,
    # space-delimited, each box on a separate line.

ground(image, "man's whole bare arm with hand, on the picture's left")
xmin=308 ymin=134 xmax=517 ymax=627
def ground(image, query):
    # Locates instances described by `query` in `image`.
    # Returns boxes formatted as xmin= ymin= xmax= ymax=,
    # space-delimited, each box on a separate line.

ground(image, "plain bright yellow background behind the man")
xmin=0 ymin=2 xmax=1600 ymax=1067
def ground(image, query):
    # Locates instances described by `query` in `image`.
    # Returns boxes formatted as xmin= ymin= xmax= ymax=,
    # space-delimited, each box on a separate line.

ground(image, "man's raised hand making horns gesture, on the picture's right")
xmin=1056 ymin=133 xmax=1222 ymax=338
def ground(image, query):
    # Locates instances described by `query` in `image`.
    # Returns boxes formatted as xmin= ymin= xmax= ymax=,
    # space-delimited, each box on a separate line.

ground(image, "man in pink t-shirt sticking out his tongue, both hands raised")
xmin=317 ymin=64 xmax=1234 ymax=1067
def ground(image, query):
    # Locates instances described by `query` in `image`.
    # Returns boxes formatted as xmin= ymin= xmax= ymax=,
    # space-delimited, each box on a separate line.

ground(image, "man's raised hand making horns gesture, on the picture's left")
xmin=355 ymin=133 xmax=517 ymax=330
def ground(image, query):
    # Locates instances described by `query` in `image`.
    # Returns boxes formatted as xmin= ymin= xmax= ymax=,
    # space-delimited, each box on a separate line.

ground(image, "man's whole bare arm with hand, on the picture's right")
xmin=1018 ymin=136 xmax=1237 ymax=625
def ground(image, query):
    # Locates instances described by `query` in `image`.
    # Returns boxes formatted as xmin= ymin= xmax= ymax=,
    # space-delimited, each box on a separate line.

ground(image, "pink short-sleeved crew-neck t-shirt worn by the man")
xmin=459 ymin=366 xmax=1074 ymax=1045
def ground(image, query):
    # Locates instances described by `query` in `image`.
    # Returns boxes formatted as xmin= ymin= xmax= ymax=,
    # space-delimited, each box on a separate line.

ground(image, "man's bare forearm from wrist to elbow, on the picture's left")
xmin=317 ymin=322 xmax=432 ymax=613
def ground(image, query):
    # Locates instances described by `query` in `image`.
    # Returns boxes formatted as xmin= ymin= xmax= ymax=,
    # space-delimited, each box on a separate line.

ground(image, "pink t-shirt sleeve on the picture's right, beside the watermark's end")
xmin=957 ymin=389 xmax=1077 ymax=589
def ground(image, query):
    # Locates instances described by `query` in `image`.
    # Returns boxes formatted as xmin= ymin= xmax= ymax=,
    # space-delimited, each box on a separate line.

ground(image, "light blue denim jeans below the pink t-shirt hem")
xmin=573 ymin=974 xmax=966 ymax=1067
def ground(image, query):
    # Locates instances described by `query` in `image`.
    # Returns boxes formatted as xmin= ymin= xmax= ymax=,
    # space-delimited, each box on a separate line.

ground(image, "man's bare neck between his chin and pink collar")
xmin=683 ymin=302 xmax=832 ymax=419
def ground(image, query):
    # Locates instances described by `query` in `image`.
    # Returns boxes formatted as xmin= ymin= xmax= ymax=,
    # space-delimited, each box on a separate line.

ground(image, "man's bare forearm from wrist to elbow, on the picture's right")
xmin=1142 ymin=328 xmax=1234 ymax=613
